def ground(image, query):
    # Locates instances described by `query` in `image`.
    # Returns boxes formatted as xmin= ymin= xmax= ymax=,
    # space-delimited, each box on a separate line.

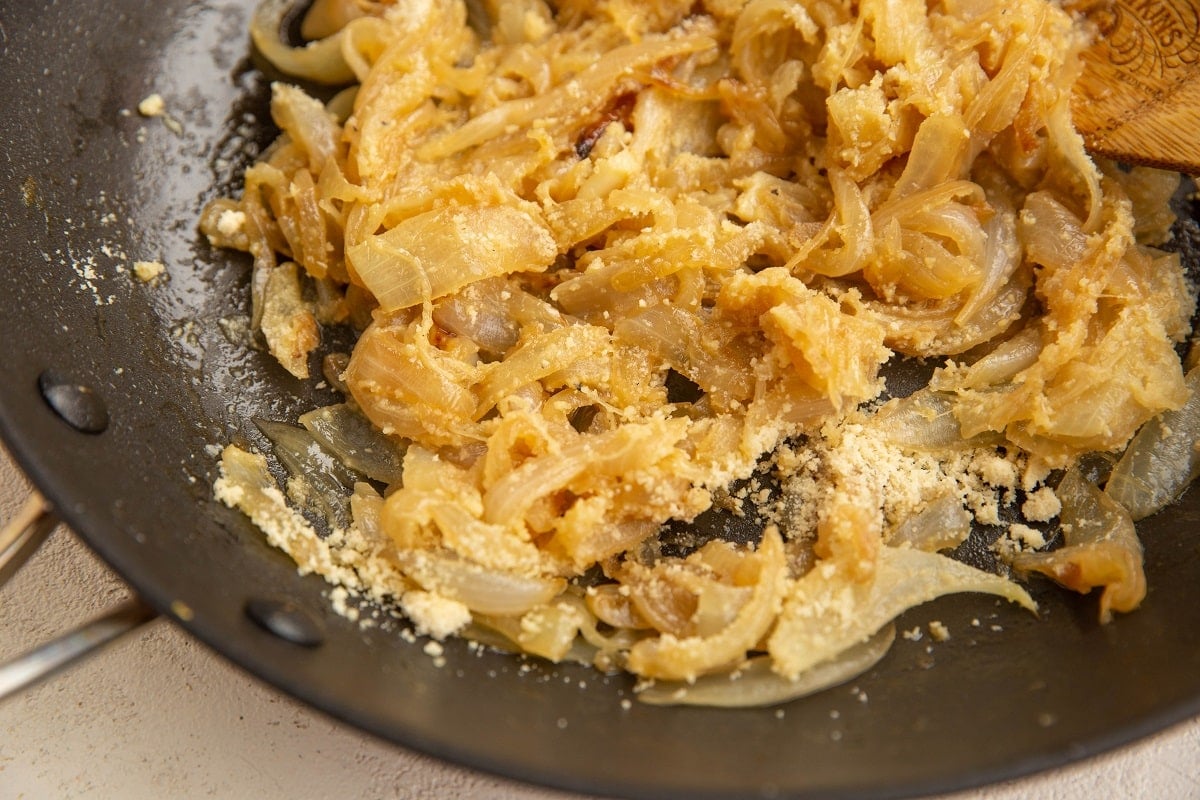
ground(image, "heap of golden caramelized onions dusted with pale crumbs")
xmin=211 ymin=0 xmax=1200 ymax=705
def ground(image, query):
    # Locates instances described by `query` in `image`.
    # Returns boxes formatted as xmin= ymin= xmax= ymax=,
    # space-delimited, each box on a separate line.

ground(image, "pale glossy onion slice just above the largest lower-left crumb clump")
xmin=396 ymin=549 xmax=566 ymax=616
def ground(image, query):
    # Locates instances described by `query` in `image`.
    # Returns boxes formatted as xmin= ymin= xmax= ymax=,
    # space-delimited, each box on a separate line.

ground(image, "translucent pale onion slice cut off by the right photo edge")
xmin=1104 ymin=368 xmax=1200 ymax=522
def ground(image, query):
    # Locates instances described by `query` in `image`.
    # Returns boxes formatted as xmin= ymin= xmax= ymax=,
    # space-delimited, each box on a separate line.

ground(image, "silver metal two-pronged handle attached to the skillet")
xmin=0 ymin=492 xmax=158 ymax=700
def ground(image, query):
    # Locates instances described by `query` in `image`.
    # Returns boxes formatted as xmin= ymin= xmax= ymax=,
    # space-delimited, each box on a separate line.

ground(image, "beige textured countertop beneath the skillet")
xmin=0 ymin=443 xmax=1200 ymax=800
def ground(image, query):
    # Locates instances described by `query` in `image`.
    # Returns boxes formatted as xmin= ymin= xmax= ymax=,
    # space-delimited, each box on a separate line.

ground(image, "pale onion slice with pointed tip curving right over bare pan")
xmin=767 ymin=547 xmax=1037 ymax=679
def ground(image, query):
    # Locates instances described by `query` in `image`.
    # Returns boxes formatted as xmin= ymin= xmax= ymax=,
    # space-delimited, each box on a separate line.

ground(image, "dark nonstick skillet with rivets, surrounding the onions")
xmin=0 ymin=0 xmax=1200 ymax=798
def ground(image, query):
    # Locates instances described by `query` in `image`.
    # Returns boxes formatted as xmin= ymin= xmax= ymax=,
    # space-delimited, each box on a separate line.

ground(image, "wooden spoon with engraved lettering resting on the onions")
xmin=1072 ymin=0 xmax=1200 ymax=175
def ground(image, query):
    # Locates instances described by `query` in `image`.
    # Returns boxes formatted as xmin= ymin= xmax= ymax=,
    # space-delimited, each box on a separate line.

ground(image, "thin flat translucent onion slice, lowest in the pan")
xmin=637 ymin=625 xmax=896 ymax=709
